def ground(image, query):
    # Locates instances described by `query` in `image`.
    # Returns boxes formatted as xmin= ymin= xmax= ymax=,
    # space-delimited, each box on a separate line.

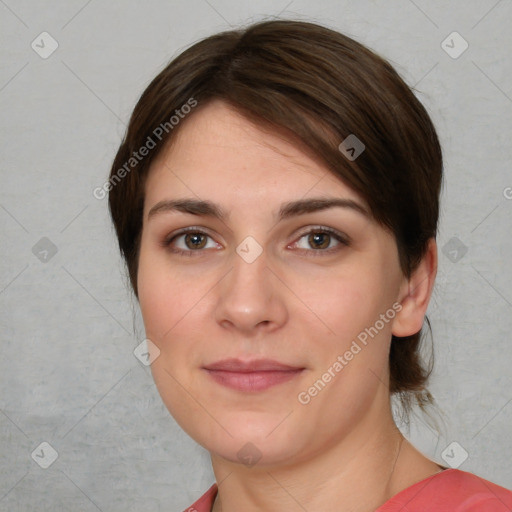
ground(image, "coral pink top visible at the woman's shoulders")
xmin=185 ymin=469 xmax=512 ymax=512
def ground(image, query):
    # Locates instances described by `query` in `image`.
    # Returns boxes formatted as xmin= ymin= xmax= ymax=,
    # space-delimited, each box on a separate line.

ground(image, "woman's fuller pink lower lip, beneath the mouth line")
xmin=203 ymin=368 xmax=302 ymax=391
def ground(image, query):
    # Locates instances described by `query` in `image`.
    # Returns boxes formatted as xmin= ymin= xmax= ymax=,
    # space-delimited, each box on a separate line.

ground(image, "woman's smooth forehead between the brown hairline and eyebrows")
xmin=145 ymin=100 xmax=365 ymax=212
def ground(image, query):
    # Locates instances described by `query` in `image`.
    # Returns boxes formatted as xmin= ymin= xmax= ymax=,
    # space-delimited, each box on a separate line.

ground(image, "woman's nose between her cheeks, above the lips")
xmin=215 ymin=248 xmax=288 ymax=336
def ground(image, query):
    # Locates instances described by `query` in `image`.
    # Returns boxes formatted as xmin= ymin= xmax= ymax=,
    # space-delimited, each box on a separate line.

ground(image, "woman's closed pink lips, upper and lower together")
xmin=204 ymin=359 xmax=304 ymax=392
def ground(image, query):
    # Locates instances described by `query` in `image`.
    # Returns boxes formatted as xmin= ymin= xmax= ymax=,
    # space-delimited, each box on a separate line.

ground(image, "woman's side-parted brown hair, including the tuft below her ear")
xmin=109 ymin=20 xmax=442 ymax=418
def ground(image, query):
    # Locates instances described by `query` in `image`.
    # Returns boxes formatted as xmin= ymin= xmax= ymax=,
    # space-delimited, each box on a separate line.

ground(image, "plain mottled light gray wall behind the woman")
xmin=0 ymin=0 xmax=512 ymax=512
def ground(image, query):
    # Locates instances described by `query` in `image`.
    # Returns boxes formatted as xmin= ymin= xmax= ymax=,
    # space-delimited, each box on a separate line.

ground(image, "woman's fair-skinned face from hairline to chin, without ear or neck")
xmin=138 ymin=101 xmax=406 ymax=465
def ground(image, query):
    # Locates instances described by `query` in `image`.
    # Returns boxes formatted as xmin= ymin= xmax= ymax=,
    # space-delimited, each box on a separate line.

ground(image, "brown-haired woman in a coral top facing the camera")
xmin=108 ymin=21 xmax=512 ymax=512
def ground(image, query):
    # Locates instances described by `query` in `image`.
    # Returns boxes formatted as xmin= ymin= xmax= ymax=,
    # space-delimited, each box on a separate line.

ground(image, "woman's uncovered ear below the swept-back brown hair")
xmin=391 ymin=238 xmax=437 ymax=337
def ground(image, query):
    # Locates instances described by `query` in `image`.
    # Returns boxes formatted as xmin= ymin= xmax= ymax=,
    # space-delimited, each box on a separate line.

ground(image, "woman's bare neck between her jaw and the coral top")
xmin=212 ymin=402 xmax=439 ymax=512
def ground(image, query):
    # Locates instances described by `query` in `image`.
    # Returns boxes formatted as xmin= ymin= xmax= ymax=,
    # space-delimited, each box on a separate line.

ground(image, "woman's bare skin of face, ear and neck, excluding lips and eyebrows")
xmin=138 ymin=101 xmax=441 ymax=512
